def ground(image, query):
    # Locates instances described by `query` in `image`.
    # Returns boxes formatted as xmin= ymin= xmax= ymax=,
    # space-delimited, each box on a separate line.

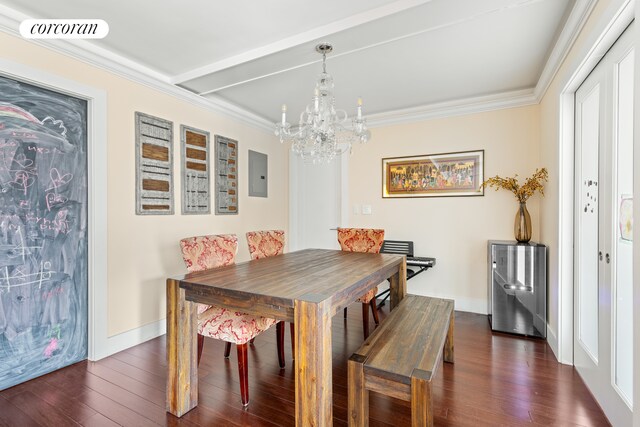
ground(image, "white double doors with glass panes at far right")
xmin=574 ymin=27 xmax=634 ymax=426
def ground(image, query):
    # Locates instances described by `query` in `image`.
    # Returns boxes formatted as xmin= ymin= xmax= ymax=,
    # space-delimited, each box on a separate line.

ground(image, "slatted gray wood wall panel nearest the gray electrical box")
xmin=215 ymin=135 xmax=238 ymax=215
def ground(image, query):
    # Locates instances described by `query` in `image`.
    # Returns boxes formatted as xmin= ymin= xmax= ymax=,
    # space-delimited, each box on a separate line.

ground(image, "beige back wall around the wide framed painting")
xmin=349 ymin=106 xmax=547 ymax=313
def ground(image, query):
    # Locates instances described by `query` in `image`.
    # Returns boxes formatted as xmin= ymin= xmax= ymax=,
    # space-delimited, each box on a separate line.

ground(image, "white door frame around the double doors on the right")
xmin=547 ymin=0 xmax=635 ymax=365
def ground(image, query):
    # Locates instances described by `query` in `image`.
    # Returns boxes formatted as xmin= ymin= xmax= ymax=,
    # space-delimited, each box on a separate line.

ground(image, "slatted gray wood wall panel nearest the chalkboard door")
xmin=135 ymin=112 xmax=174 ymax=215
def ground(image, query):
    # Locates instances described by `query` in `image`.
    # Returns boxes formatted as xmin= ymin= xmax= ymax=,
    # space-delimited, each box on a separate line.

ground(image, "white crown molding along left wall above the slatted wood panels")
xmin=0 ymin=5 xmax=273 ymax=133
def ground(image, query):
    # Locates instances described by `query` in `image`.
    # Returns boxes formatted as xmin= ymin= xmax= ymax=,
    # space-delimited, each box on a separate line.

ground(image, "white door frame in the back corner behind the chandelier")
xmin=288 ymin=144 xmax=350 ymax=251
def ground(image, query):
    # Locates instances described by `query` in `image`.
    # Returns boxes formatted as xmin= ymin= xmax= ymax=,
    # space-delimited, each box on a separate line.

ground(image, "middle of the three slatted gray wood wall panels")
xmin=180 ymin=125 xmax=211 ymax=214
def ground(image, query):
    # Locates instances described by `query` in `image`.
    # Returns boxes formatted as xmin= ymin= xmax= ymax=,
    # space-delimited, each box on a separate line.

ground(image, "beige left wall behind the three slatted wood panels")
xmin=0 ymin=33 xmax=288 ymax=336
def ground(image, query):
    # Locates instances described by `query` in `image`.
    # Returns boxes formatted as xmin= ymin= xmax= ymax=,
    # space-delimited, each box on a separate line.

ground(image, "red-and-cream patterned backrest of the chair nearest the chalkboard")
xmin=180 ymin=234 xmax=238 ymax=273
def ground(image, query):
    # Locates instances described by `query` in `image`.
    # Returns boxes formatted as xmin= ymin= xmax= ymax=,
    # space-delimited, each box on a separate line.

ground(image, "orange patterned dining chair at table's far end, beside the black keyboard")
xmin=338 ymin=228 xmax=384 ymax=339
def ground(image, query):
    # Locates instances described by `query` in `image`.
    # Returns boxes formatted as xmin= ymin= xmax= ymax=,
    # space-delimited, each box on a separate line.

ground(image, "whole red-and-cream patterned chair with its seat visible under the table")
xmin=180 ymin=234 xmax=284 ymax=406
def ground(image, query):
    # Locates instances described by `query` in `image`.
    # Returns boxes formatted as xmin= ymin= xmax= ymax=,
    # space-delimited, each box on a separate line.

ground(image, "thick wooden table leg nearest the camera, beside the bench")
xmin=294 ymin=295 xmax=333 ymax=427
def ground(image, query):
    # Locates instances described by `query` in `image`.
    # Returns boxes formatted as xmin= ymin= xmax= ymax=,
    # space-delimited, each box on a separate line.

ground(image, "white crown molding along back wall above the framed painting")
xmin=367 ymin=89 xmax=538 ymax=128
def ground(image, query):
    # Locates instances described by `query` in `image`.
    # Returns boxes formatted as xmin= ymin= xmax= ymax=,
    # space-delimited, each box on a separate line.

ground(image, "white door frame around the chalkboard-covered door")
xmin=0 ymin=58 xmax=109 ymax=360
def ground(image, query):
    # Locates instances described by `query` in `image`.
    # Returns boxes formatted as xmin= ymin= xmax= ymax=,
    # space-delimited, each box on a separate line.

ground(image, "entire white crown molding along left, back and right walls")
xmin=0 ymin=0 xmax=597 ymax=133
